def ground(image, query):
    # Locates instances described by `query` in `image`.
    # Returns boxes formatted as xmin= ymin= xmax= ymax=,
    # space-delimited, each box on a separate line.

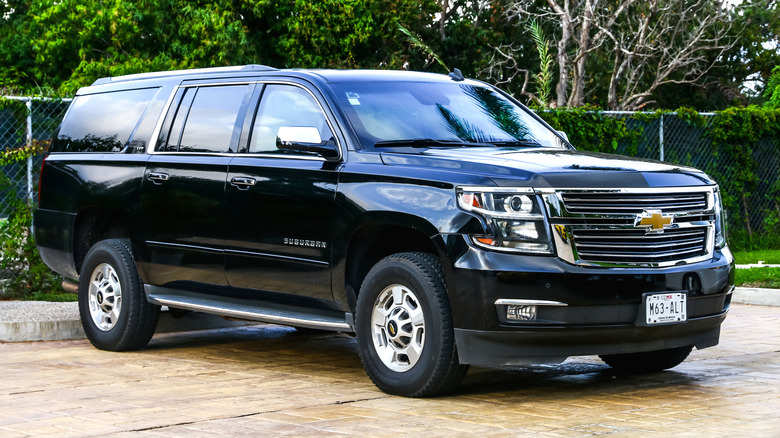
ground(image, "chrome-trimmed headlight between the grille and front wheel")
xmin=457 ymin=187 xmax=552 ymax=254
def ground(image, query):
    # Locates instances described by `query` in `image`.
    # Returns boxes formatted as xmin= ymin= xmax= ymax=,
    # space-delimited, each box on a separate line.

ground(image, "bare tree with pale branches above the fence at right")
xmin=502 ymin=0 xmax=734 ymax=110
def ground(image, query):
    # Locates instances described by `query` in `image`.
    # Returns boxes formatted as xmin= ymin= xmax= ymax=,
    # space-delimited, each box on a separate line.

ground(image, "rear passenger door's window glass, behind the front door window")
xmin=179 ymin=85 xmax=248 ymax=152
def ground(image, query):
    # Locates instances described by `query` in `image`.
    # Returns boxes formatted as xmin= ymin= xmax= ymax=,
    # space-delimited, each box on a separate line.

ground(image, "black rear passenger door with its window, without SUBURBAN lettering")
xmin=141 ymin=84 xmax=254 ymax=287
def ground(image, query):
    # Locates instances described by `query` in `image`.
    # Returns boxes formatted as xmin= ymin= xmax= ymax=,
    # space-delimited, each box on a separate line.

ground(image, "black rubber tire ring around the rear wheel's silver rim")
xmin=78 ymin=240 xmax=145 ymax=351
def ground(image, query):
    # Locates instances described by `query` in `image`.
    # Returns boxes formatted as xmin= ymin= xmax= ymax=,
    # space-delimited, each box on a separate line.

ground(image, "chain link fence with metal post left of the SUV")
xmin=0 ymin=97 xmax=71 ymax=219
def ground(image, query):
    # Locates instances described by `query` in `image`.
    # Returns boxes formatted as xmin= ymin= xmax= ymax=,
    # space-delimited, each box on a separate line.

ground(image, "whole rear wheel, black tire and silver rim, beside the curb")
xmin=79 ymin=239 xmax=160 ymax=351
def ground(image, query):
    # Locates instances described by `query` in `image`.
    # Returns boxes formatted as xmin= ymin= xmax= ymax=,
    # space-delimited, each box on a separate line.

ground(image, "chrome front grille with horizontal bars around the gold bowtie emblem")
xmin=546 ymin=187 xmax=716 ymax=267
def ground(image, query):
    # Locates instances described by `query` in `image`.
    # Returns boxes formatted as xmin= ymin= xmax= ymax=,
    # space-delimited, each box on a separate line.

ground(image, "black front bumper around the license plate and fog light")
xmin=448 ymin=236 xmax=734 ymax=366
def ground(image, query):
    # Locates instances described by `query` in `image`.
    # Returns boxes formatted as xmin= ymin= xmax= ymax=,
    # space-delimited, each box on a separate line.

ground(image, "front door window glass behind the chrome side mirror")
xmin=249 ymin=85 xmax=333 ymax=153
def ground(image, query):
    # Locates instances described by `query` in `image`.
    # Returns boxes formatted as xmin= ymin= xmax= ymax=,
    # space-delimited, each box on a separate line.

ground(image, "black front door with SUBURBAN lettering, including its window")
xmin=225 ymin=83 xmax=339 ymax=305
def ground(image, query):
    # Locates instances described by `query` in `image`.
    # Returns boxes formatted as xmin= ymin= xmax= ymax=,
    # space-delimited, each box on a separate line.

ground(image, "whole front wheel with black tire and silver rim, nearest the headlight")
xmin=355 ymin=253 xmax=468 ymax=397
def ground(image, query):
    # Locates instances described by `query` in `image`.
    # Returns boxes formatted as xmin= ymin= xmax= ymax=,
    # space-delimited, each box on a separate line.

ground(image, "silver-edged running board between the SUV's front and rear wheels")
xmin=144 ymin=284 xmax=353 ymax=332
